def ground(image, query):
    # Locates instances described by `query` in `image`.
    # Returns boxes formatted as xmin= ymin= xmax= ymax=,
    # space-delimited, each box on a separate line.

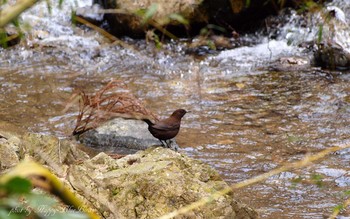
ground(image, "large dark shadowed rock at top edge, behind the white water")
xmin=93 ymin=0 xmax=304 ymax=37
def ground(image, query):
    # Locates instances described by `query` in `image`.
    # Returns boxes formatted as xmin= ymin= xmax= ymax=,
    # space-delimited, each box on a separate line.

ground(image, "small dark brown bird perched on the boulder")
xmin=143 ymin=109 xmax=187 ymax=147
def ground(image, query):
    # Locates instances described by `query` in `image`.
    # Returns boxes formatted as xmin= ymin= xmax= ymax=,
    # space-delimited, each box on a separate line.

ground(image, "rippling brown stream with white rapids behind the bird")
xmin=0 ymin=0 xmax=350 ymax=218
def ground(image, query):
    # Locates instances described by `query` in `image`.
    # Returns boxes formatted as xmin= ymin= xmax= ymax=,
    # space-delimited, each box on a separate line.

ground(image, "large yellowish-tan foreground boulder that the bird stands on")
xmin=68 ymin=147 xmax=257 ymax=218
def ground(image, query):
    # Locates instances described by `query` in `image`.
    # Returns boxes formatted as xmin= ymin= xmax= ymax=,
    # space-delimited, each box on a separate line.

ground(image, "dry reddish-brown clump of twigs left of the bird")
xmin=69 ymin=80 xmax=157 ymax=135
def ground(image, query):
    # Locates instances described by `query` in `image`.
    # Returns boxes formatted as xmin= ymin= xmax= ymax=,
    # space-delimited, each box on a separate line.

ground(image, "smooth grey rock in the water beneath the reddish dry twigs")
xmin=79 ymin=118 xmax=178 ymax=154
